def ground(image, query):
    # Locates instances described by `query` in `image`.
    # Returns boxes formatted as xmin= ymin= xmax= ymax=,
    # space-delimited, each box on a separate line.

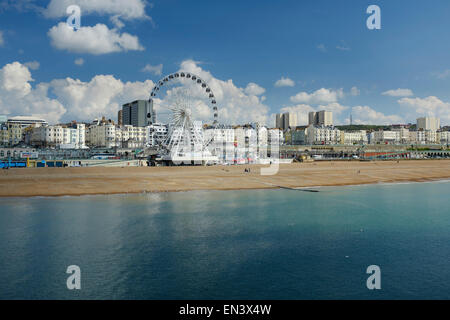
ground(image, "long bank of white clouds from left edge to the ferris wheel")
xmin=0 ymin=62 xmax=153 ymax=123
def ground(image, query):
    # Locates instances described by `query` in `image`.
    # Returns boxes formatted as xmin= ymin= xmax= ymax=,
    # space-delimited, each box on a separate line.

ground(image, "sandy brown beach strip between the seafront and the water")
xmin=0 ymin=160 xmax=450 ymax=197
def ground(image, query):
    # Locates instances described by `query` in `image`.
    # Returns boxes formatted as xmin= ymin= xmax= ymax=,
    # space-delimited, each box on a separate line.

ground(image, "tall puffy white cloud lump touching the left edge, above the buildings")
xmin=0 ymin=62 xmax=66 ymax=122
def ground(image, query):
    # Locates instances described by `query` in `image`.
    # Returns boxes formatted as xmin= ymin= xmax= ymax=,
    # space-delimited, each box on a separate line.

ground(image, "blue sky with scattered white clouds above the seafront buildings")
xmin=0 ymin=0 xmax=450 ymax=126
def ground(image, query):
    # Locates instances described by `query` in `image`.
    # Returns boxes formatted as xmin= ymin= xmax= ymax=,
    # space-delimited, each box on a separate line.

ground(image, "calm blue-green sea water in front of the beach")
xmin=0 ymin=182 xmax=450 ymax=299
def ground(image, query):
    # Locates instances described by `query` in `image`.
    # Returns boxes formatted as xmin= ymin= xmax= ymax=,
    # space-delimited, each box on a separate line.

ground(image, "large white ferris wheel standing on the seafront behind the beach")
xmin=148 ymin=72 xmax=218 ymax=160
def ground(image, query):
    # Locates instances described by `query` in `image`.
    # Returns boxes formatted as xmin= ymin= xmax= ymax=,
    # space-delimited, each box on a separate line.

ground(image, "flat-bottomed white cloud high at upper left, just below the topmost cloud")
xmin=48 ymin=22 xmax=144 ymax=55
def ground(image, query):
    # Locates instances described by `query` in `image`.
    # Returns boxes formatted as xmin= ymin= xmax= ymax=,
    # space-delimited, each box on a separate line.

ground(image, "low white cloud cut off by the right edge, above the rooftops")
xmin=398 ymin=96 xmax=450 ymax=124
